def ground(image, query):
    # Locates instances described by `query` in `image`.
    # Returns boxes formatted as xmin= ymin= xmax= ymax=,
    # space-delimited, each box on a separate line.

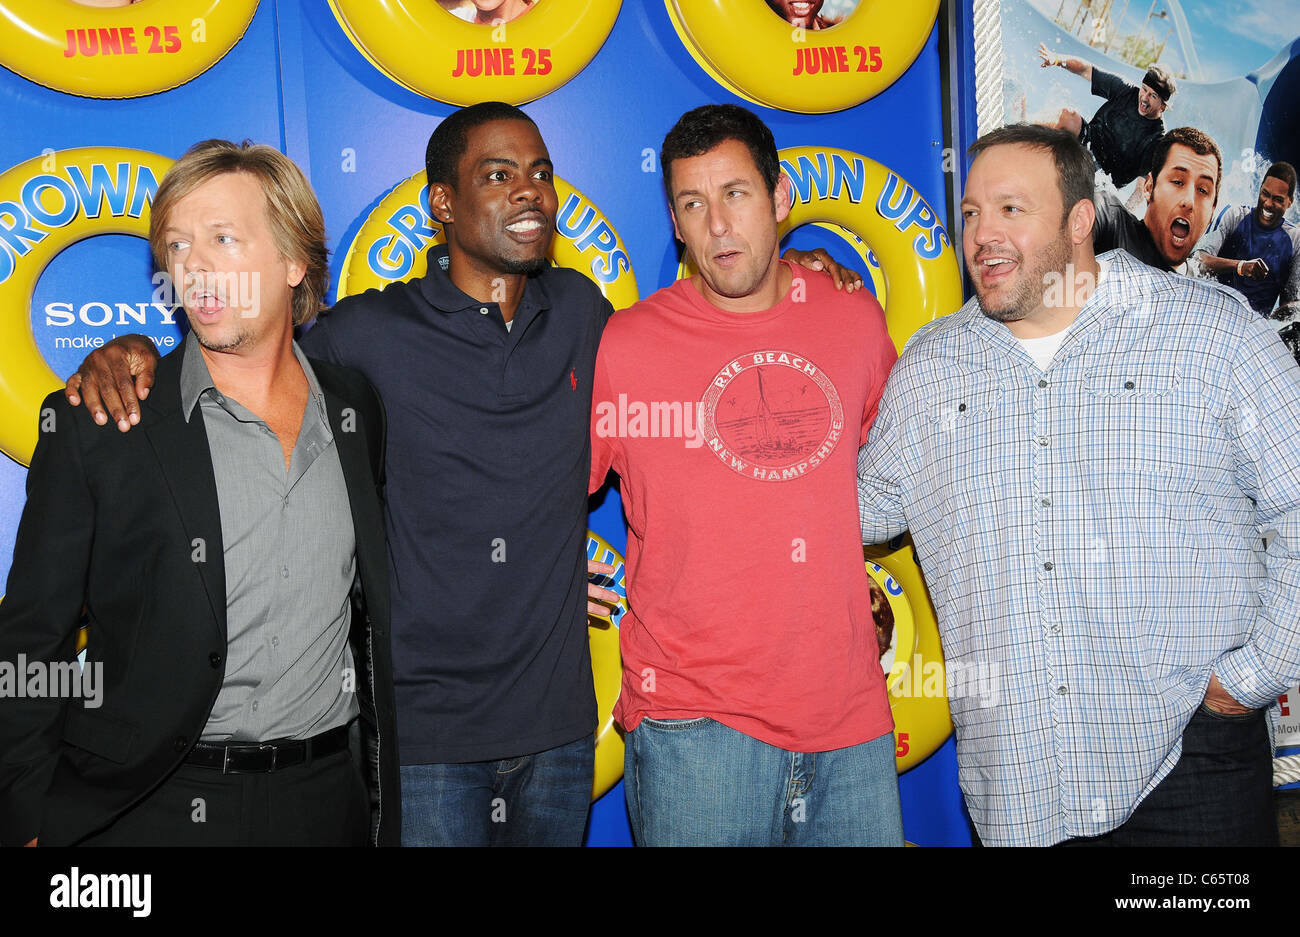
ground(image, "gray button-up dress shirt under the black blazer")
xmin=181 ymin=333 xmax=358 ymax=742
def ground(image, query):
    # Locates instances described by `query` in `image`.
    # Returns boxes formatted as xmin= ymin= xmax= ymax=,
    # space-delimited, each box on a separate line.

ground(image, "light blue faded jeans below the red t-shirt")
xmin=624 ymin=716 xmax=902 ymax=846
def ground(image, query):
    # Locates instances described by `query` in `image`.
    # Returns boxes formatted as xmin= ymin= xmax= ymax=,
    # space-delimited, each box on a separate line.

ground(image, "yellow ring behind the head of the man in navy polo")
xmin=338 ymin=169 xmax=640 ymax=309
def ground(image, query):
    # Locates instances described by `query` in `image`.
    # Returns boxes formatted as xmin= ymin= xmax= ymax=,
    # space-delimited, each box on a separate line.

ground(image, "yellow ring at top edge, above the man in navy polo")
xmin=329 ymin=0 xmax=621 ymax=105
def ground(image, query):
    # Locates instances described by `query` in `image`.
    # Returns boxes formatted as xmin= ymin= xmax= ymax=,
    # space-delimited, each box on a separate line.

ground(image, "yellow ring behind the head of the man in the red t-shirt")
xmin=677 ymin=147 xmax=962 ymax=351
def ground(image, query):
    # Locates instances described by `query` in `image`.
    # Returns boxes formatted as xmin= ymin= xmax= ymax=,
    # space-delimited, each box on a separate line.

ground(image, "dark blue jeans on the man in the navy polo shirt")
xmin=402 ymin=736 xmax=595 ymax=846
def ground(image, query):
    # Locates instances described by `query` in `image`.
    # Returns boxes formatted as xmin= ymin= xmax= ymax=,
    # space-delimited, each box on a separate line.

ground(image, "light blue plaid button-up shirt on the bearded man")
xmin=858 ymin=252 xmax=1300 ymax=845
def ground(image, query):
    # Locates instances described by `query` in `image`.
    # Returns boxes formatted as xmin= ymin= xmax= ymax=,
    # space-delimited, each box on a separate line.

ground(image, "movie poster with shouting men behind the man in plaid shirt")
xmin=975 ymin=0 xmax=1300 ymax=750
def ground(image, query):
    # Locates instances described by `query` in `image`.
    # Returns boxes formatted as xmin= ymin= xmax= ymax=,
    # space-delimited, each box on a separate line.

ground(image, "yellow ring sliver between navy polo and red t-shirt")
xmin=586 ymin=530 xmax=628 ymax=801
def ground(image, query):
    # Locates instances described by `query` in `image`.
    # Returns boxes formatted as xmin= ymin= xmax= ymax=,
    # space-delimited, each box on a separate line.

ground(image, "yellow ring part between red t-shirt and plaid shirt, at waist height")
xmin=863 ymin=538 xmax=953 ymax=773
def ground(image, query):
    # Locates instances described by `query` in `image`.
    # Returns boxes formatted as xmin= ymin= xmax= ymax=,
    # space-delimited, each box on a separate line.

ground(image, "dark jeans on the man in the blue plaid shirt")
xmin=1061 ymin=704 xmax=1278 ymax=846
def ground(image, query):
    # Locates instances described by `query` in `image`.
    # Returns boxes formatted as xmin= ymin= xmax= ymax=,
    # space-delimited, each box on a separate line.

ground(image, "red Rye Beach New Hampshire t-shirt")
xmin=592 ymin=261 xmax=897 ymax=751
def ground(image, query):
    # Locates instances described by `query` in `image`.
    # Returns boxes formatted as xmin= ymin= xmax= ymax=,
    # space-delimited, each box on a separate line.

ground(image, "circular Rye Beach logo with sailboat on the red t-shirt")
xmin=699 ymin=350 xmax=844 ymax=481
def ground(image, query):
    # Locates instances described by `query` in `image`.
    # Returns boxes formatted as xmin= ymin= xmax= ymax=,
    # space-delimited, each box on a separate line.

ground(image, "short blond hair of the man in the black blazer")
xmin=150 ymin=140 xmax=329 ymax=325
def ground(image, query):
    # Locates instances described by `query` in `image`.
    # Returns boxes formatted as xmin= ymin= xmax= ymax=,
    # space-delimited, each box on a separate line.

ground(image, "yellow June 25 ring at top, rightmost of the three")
xmin=664 ymin=0 xmax=939 ymax=114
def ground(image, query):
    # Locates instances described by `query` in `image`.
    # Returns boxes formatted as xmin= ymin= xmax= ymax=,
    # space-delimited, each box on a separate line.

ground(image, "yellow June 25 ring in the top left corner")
xmin=0 ymin=0 xmax=257 ymax=97
